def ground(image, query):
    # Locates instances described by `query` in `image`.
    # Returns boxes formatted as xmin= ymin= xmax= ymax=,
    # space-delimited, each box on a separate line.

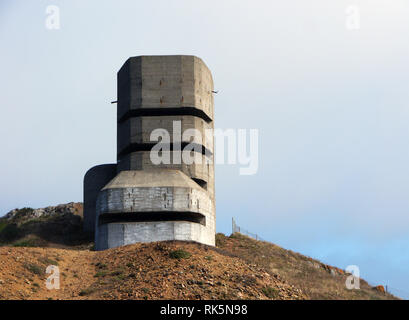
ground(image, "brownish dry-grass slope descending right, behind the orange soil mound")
xmin=216 ymin=233 xmax=395 ymax=300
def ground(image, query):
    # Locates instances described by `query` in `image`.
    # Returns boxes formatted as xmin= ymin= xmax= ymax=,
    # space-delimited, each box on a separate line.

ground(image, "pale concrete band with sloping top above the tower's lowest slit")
xmin=97 ymin=169 xmax=214 ymax=216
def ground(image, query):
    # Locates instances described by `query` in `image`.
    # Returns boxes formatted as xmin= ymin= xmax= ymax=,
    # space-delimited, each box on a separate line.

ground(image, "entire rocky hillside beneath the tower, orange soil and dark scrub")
xmin=0 ymin=203 xmax=395 ymax=299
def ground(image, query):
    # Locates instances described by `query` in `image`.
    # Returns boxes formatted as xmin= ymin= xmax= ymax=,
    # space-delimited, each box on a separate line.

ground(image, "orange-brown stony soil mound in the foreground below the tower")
xmin=0 ymin=242 xmax=307 ymax=299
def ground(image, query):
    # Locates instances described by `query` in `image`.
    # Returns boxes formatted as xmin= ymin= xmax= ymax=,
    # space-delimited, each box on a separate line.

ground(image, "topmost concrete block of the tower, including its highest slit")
xmin=117 ymin=55 xmax=214 ymax=122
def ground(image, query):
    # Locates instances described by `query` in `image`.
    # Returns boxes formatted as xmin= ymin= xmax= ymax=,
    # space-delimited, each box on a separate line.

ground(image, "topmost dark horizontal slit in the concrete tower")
xmin=118 ymin=107 xmax=212 ymax=123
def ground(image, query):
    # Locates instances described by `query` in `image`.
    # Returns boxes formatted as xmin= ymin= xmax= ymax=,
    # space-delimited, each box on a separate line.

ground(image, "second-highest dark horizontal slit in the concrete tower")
xmin=118 ymin=142 xmax=213 ymax=157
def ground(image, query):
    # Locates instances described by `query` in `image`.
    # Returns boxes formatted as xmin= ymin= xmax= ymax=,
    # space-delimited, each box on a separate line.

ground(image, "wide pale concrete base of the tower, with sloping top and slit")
xmin=91 ymin=169 xmax=216 ymax=250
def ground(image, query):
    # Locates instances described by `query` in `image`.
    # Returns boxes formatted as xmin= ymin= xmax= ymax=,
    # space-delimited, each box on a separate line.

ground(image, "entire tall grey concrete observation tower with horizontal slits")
xmin=84 ymin=55 xmax=216 ymax=250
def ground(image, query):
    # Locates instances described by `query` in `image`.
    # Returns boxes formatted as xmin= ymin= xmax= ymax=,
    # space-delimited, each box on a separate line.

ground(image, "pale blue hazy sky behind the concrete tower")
xmin=0 ymin=0 xmax=409 ymax=298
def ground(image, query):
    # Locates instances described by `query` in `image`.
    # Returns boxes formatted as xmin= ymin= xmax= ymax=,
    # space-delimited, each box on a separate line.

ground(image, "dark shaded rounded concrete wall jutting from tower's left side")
xmin=83 ymin=164 xmax=117 ymax=233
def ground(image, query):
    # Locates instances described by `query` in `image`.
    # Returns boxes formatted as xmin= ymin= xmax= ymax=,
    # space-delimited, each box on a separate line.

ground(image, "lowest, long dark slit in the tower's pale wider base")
xmin=98 ymin=211 xmax=206 ymax=226
